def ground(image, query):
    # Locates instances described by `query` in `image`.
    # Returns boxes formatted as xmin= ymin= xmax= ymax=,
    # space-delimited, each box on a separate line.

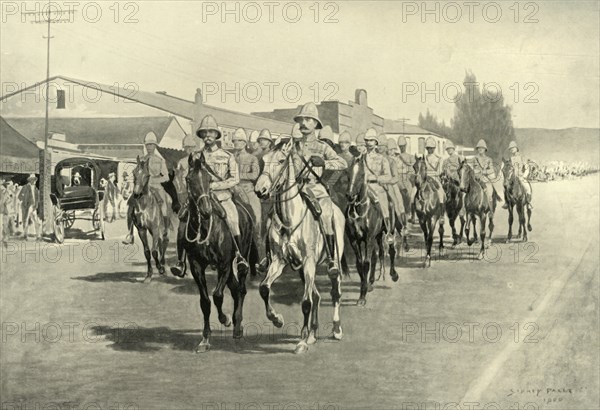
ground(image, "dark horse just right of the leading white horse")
xmin=342 ymin=151 xmax=398 ymax=306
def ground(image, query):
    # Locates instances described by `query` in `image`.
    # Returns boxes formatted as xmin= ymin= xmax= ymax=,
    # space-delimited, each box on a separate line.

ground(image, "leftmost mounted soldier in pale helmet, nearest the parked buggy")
xmin=123 ymin=131 xmax=177 ymax=245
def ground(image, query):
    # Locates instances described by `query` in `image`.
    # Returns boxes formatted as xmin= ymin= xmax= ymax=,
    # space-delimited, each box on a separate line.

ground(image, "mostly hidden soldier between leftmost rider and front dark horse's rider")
xmin=171 ymin=134 xmax=204 ymax=278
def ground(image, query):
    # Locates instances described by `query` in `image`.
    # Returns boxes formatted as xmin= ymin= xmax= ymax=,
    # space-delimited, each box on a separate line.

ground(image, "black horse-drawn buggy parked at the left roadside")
xmin=50 ymin=158 xmax=104 ymax=243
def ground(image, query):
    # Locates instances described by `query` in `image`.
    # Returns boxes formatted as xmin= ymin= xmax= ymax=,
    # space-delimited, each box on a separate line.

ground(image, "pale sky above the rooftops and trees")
xmin=0 ymin=0 xmax=600 ymax=128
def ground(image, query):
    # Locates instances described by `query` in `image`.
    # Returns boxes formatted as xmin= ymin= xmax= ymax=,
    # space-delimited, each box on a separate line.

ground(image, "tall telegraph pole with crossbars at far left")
xmin=21 ymin=0 xmax=75 ymax=226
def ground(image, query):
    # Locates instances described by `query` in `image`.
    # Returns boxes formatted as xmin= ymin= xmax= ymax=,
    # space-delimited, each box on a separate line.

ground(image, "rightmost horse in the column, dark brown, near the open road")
xmin=502 ymin=159 xmax=532 ymax=243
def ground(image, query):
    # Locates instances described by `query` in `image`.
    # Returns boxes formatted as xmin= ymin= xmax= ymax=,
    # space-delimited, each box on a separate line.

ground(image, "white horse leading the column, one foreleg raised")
xmin=255 ymin=141 xmax=345 ymax=353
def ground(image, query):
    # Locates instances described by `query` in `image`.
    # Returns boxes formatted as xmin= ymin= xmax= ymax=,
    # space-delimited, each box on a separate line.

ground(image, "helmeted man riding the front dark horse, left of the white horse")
xmin=196 ymin=115 xmax=248 ymax=270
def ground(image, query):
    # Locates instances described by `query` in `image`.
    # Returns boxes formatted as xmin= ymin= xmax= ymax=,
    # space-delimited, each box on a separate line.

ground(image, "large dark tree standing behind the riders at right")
xmin=451 ymin=72 xmax=515 ymax=159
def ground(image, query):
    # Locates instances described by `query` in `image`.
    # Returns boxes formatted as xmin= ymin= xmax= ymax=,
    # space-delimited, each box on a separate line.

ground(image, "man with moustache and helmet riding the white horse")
xmin=294 ymin=102 xmax=347 ymax=274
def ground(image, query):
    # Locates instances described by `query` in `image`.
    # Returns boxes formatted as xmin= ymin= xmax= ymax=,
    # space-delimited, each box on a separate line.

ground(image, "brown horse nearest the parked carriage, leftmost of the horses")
xmin=129 ymin=156 xmax=170 ymax=283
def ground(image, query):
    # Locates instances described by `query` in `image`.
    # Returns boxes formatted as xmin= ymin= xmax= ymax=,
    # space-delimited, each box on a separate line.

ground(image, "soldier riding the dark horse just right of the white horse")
xmin=364 ymin=128 xmax=394 ymax=242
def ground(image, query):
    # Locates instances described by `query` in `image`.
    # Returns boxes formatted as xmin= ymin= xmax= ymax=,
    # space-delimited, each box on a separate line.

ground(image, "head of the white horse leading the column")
xmin=254 ymin=141 xmax=293 ymax=198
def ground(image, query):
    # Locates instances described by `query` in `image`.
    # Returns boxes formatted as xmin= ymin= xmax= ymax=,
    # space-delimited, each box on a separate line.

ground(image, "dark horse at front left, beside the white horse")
xmin=182 ymin=155 xmax=258 ymax=353
